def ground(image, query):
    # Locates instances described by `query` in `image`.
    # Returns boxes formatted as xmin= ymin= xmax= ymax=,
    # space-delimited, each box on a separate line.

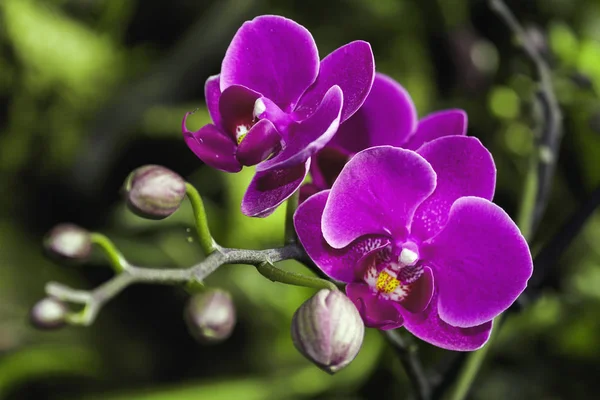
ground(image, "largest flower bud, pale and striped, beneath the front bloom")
xmin=292 ymin=289 xmax=365 ymax=374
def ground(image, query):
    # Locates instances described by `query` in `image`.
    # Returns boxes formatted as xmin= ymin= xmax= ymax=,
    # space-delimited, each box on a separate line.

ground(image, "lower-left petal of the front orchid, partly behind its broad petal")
xmin=294 ymin=190 xmax=389 ymax=282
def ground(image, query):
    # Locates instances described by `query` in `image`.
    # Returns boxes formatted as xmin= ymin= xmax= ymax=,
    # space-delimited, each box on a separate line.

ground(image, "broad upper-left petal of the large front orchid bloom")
xmin=322 ymin=146 xmax=436 ymax=248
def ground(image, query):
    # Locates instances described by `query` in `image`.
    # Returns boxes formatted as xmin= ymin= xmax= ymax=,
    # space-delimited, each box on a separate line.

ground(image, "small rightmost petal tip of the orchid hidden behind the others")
xmin=402 ymin=110 xmax=467 ymax=150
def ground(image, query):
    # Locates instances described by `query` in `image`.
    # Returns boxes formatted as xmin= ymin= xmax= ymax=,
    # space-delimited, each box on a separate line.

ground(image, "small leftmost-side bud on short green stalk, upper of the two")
xmin=44 ymin=224 xmax=92 ymax=261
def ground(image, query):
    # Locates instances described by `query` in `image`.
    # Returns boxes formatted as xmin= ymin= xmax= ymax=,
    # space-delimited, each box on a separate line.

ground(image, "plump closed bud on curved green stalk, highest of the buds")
xmin=125 ymin=165 xmax=185 ymax=219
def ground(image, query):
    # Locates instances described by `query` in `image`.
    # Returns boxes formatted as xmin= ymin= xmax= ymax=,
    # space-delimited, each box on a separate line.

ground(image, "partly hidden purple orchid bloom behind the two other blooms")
xmin=301 ymin=73 xmax=467 ymax=200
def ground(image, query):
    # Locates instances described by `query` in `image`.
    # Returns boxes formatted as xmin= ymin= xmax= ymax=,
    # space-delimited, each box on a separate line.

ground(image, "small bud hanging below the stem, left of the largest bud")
xmin=185 ymin=289 xmax=236 ymax=343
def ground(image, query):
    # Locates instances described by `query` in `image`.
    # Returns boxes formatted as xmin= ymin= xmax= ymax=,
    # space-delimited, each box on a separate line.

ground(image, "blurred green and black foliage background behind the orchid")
xmin=0 ymin=0 xmax=600 ymax=400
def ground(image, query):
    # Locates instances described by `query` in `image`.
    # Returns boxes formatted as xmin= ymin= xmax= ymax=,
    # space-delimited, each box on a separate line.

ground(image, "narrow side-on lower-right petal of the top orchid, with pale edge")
xmin=256 ymin=86 xmax=344 ymax=171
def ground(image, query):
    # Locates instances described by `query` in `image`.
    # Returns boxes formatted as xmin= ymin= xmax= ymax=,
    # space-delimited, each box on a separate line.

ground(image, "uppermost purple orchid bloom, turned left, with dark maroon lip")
xmin=182 ymin=15 xmax=375 ymax=217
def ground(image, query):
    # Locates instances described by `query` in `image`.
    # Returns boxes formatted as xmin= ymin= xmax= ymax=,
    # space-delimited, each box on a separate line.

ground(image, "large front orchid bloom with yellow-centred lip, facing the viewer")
xmin=294 ymin=141 xmax=533 ymax=351
